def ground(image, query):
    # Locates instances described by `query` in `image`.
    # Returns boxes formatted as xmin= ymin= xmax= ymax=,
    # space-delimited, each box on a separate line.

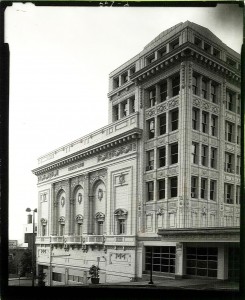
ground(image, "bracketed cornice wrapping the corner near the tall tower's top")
xmin=130 ymin=42 xmax=241 ymax=84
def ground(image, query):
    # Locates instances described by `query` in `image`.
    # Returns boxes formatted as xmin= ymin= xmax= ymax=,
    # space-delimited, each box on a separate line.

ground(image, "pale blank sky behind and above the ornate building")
xmin=5 ymin=3 xmax=243 ymax=242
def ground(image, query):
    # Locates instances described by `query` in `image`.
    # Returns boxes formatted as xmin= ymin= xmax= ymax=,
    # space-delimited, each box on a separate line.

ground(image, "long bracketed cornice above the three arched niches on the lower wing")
xmin=32 ymin=128 xmax=142 ymax=177
